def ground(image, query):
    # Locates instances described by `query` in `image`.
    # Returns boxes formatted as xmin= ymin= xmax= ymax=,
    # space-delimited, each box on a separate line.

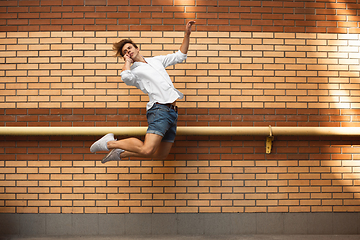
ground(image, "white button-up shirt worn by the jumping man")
xmin=120 ymin=50 xmax=187 ymax=110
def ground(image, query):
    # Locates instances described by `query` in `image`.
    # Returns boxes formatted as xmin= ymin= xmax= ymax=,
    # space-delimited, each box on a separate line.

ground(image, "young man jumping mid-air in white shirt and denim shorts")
xmin=90 ymin=21 xmax=195 ymax=163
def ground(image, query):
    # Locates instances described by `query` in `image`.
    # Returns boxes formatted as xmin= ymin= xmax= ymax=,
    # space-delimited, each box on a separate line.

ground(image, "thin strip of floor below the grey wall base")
xmin=0 ymin=235 xmax=360 ymax=240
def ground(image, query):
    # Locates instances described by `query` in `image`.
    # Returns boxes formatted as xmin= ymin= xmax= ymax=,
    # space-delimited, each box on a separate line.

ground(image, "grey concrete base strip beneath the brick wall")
xmin=0 ymin=213 xmax=360 ymax=237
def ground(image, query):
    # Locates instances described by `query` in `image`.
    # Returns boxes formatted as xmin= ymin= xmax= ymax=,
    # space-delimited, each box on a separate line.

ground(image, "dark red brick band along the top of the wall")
xmin=0 ymin=0 xmax=359 ymax=33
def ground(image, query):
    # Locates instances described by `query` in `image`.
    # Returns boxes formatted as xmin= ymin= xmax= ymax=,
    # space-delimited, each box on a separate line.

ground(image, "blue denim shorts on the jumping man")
xmin=146 ymin=104 xmax=178 ymax=142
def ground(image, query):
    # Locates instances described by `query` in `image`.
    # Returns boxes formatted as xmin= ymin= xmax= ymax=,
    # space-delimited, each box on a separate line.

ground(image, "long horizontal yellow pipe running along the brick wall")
xmin=0 ymin=126 xmax=360 ymax=136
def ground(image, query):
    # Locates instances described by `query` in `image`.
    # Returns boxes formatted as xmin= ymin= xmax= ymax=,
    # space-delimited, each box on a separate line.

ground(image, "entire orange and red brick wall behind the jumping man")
xmin=0 ymin=0 xmax=360 ymax=213
